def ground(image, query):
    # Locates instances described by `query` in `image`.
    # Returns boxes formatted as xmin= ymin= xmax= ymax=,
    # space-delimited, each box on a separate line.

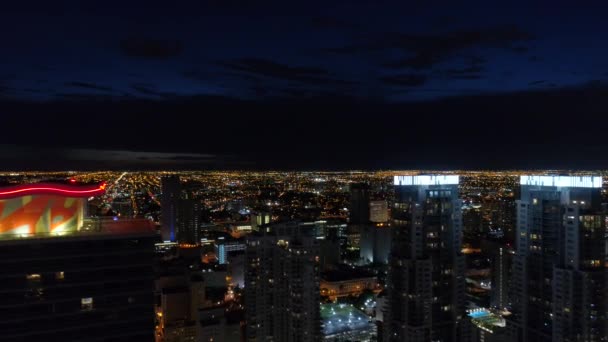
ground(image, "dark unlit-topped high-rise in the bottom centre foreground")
xmin=245 ymin=222 xmax=321 ymax=342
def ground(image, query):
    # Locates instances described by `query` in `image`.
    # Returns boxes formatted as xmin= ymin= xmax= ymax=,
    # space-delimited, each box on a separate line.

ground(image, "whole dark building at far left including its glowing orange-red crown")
xmin=0 ymin=183 xmax=157 ymax=341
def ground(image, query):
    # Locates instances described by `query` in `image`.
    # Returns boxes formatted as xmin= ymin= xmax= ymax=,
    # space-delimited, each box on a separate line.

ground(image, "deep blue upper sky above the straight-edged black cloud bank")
xmin=0 ymin=0 xmax=608 ymax=102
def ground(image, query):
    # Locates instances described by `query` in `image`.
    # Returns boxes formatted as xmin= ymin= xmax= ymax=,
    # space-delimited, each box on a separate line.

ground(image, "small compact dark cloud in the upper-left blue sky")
xmin=119 ymin=38 xmax=183 ymax=59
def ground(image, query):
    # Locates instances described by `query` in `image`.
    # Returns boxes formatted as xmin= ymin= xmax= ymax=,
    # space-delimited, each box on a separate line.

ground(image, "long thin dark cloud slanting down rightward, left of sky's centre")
xmin=218 ymin=58 xmax=354 ymax=85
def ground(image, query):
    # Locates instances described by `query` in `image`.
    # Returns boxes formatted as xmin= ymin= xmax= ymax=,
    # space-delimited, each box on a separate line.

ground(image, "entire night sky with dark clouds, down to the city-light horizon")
xmin=0 ymin=0 xmax=608 ymax=169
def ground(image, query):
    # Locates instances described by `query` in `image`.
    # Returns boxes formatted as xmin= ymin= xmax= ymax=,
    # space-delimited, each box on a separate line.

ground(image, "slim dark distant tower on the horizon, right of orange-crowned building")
xmin=160 ymin=175 xmax=181 ymax=241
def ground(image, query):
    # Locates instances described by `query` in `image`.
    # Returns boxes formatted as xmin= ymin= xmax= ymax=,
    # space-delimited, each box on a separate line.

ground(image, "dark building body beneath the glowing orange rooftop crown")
xmin=0 ymin=218 xmax=157 ymax=341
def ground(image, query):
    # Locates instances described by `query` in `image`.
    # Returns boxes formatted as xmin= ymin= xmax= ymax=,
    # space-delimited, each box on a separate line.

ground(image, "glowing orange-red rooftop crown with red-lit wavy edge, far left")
xmin=0 ymin=183 xmax=105 ymax=237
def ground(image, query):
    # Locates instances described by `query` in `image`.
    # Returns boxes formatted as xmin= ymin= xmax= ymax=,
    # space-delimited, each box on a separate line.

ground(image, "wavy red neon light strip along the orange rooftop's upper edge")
xmin=0 ymin=183 xmax=106 ymax=199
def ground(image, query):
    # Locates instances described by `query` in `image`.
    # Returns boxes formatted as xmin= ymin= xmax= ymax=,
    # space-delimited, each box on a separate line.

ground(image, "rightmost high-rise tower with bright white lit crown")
xmin=512 ymin=176 xmax=608 ymax=342
